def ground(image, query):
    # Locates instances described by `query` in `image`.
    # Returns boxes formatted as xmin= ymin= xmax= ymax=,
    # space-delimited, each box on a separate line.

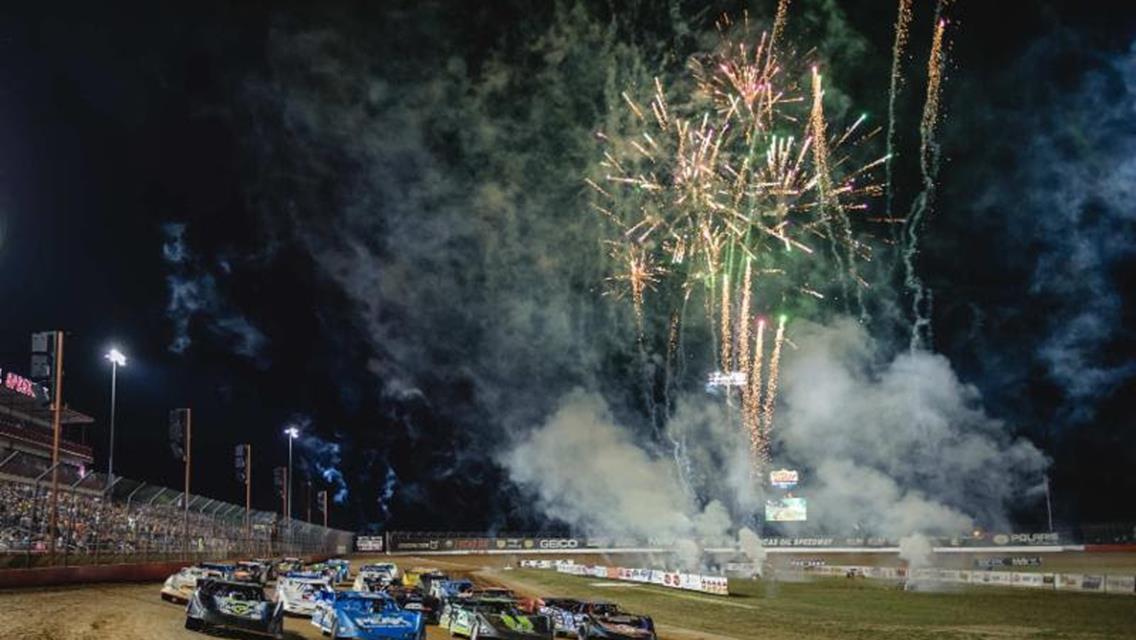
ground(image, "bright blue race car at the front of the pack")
xmin=311 ymin=591 xmax=426 ymax=640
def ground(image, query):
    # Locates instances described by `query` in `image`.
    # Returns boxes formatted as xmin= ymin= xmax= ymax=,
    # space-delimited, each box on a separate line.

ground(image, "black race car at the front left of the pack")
xmin=185 ymin=579 xmax=284 ymax=638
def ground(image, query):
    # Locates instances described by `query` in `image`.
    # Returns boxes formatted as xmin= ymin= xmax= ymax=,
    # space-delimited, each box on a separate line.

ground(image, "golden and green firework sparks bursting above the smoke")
xmin=587 ymin=0 xmax=946 ymax=486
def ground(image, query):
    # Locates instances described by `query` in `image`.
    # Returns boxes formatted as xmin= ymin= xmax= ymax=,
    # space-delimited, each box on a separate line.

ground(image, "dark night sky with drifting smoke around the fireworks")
xmin=0 ymin=0 xmax=1136 ymax=530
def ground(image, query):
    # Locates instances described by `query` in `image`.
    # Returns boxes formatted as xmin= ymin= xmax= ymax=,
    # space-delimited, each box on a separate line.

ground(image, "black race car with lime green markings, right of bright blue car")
xmin=438 ymin=598 xmax=552 ymax=640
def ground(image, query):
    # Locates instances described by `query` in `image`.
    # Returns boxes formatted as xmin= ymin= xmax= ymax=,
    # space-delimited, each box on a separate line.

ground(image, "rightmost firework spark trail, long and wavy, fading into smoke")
xmin=903 ymin=0 xmax=950 ymax=351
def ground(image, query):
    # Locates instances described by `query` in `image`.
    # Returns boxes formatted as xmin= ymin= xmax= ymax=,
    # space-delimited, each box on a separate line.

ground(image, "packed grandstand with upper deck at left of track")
xmin=0 ymin=363 xmax=351 ymax=568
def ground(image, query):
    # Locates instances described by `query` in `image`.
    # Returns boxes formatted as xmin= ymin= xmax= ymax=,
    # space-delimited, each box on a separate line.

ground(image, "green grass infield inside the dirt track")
xmin=506 ymin=570 xmax=1136 ymax=640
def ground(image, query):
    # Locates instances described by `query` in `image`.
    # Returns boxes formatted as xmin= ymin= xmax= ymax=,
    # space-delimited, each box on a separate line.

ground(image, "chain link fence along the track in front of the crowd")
xmin=0 ymin=452 xmax=354 ymax=568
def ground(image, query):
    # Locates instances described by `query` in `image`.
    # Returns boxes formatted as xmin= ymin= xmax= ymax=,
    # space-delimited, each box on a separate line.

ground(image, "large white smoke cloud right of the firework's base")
xmin=777 ymin=321 xmax=1046 ymax=537
